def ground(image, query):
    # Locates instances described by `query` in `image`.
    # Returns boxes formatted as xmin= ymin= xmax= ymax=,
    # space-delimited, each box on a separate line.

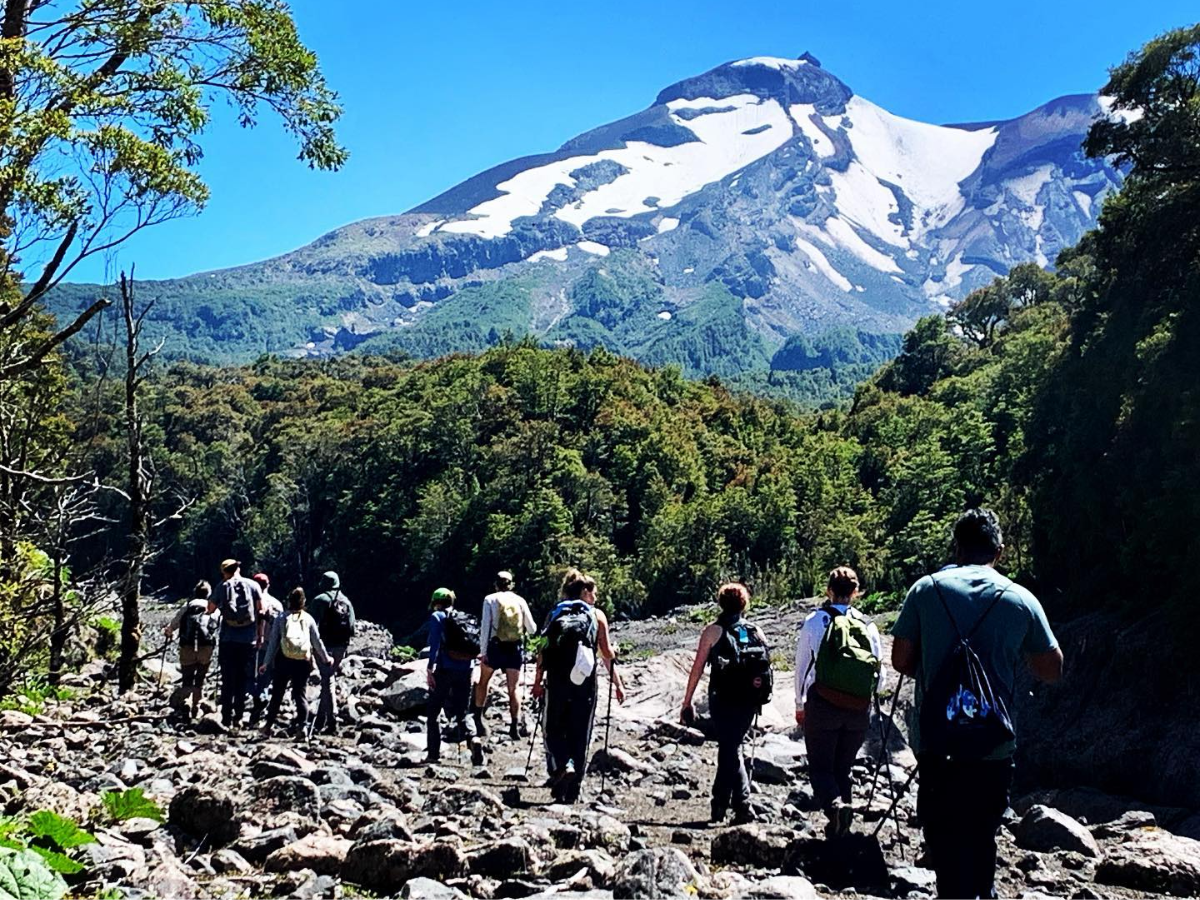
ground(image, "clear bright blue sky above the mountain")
xmin=72 ymin=0 xmax=1198 ymax=281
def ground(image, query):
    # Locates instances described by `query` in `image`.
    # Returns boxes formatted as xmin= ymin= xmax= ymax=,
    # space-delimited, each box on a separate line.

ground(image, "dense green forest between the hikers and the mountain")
xmin=0 ymin=26 xmax=1200 ymax=691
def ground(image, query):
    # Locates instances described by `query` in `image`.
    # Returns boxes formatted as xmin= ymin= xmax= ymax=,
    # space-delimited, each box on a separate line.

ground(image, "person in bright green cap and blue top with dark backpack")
xmin=425 ymin=588 xmax=479 ymax=763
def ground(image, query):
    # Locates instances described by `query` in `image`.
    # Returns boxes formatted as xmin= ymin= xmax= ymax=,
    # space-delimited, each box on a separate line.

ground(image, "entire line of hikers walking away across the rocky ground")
xmin=168 ymin=509 xmax=1063 ymax=898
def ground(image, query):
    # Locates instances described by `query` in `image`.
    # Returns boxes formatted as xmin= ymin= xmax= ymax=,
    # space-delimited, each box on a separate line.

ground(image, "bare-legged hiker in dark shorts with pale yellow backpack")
xmin=474 ymin=572 xmax=538 ymax=740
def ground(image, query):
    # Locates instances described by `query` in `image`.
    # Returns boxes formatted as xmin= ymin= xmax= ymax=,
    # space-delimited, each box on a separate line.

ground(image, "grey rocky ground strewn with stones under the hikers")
xmin=0 ymin=602 xmax=1200 ymax=899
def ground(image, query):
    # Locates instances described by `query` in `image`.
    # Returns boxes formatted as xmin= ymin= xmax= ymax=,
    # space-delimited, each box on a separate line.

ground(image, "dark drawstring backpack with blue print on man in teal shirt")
xmin=920 ymin=576 xmax=1016 ymax=760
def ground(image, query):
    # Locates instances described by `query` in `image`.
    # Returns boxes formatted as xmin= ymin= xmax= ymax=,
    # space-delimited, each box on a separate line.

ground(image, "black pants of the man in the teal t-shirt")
xmin=917 ymin=755 xmax=1013 ymax=898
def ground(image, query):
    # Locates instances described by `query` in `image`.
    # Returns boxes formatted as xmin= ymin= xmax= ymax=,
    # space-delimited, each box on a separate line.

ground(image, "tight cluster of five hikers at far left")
xmin=163 ymin=559 xmax=358 ymax=734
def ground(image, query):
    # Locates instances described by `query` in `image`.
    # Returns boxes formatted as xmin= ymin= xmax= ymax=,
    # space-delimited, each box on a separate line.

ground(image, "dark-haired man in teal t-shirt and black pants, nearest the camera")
xmin=892 ymin=509 xmax=1062 ymax=898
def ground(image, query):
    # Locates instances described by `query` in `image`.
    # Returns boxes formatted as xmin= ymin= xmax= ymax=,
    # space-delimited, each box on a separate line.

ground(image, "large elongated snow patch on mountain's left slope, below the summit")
xmin=442 ymin=94 xmax=792 ymax=238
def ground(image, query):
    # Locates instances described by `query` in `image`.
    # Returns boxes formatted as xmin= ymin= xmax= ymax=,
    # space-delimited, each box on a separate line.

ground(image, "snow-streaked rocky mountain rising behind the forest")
xmin=52 ymin=54 xmax=1122 ymax=374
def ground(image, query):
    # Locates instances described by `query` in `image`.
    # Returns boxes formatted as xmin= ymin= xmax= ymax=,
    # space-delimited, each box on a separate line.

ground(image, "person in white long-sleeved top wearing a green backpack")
xmin=796 ymin=565 xmax=883 ymax=838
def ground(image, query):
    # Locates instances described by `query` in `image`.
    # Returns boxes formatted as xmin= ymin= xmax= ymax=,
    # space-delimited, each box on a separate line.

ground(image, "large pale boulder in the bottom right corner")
xmin=1096 ymin=828 xmax=1200 ymax=896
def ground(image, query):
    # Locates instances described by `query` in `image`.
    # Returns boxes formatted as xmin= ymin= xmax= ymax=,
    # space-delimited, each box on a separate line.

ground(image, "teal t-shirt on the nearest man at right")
xmin=892 ymin=565 xmax=1058 ymax=760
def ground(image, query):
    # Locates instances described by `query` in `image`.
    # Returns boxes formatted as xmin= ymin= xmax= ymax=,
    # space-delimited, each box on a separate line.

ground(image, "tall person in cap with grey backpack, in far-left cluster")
xmin=216 ymin=559 xmax=264 ymax=728
